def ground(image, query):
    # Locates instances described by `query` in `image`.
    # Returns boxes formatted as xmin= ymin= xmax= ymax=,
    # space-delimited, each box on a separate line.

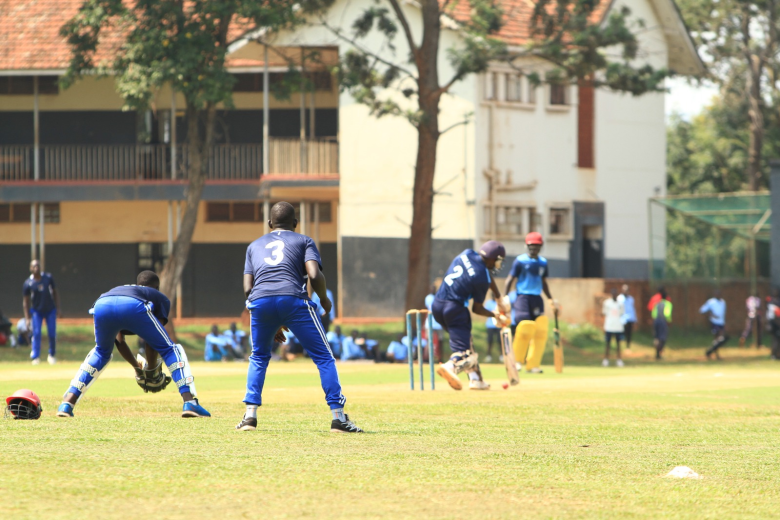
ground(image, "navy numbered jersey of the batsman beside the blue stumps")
xmin=436 ymin=249 xmax=490 ymax=305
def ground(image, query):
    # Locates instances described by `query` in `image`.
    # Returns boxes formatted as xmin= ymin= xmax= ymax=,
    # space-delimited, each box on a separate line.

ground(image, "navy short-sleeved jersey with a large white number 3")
xmin=244 ymin=230 xmax=322 ymax=302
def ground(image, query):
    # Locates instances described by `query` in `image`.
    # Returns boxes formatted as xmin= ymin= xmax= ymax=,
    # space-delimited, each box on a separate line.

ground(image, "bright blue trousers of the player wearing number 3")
xmin=244 ymin=296 xmax=347 ymax=409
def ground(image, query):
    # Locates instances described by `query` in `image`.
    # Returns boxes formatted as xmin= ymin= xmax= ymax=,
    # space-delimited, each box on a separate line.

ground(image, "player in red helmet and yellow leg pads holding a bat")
xmin=504 ymin=231 xmax=556 ymax=374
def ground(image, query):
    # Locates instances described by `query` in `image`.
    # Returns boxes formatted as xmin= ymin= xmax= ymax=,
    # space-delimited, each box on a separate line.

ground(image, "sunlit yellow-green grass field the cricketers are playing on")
xmin=0 ymin=327 xmax=780 ymax=518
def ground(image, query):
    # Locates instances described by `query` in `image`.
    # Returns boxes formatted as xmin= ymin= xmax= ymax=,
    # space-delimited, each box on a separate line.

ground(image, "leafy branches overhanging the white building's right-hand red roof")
xmin=527 ymin=0 xmax=669 ymax=96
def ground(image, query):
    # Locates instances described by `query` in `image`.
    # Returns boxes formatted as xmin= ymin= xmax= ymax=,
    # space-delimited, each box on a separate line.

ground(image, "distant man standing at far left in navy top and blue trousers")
xmin=22 ymin=260 xmax=62 ymax=365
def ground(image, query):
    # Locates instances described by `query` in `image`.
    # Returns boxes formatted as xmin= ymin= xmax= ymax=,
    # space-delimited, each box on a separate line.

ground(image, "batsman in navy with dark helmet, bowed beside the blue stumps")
xmin=431 ymin=240 xmax=506 ymax=390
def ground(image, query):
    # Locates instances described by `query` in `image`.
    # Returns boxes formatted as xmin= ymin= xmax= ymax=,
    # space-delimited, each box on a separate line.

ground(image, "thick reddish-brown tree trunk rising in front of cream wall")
xmin=406 ymin=0 xmax=441 ymax=309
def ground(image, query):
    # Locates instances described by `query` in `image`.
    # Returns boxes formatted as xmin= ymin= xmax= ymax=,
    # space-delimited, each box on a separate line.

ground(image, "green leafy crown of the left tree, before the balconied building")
xmin=61 ymin=0 xmax=318 ymax=110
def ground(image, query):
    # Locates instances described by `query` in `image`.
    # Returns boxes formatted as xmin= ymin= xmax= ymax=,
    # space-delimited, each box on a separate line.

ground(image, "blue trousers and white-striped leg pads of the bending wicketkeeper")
xmin=68 ymin=296 xmax=194 ymax=396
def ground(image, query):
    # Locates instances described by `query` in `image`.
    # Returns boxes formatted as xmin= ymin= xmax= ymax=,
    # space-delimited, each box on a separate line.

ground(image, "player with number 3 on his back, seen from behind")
xmin=236 ymin=202 xmax=363 ymax=433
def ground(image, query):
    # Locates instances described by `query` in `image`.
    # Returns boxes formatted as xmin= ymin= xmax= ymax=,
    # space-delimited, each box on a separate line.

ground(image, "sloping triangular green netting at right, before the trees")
xmin=652 ymin=192 xmax=771 ymax=242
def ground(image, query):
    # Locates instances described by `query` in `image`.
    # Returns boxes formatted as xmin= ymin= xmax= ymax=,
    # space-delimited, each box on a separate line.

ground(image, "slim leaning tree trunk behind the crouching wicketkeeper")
xmin=160 ymin=103 xmax=216 ymax=308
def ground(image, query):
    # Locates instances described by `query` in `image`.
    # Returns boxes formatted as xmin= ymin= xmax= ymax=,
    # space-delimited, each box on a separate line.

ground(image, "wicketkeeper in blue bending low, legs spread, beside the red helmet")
xmin=57 ymin=271 xmax=211 ymax=417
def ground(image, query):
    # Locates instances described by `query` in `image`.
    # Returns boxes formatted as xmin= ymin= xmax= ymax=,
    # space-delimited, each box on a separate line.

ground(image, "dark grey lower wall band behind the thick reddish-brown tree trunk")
xmin=341 ymin=237 xmax=473 ymax=318
